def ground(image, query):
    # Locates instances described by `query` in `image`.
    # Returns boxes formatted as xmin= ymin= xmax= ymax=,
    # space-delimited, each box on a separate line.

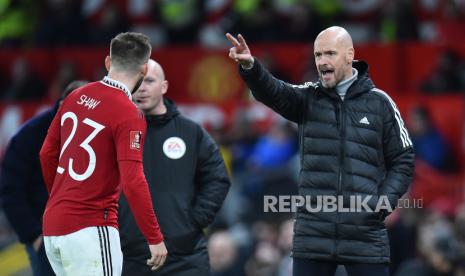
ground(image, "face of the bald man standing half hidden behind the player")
xmin=133 ymin=60 xmax=168 ymax=115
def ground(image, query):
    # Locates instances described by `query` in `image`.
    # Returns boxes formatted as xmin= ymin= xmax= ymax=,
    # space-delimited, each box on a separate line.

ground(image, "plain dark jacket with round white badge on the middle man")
xmin=119 ymin=99 xmax=230 ymax=276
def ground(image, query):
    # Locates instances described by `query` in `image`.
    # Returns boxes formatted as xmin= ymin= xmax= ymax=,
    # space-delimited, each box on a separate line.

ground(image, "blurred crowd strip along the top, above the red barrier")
xmin=0 ymin=0 xmax=465 ymax=47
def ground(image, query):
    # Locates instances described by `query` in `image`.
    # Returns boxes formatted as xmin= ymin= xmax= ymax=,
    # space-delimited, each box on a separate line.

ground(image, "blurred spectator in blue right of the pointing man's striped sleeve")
xmin=408 ymin=106 xmax=457 ymax=172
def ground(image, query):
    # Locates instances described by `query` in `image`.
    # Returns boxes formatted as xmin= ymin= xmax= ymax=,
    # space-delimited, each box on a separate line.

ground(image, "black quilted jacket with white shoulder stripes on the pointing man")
xmin=240 ymin=60 xmax=414 ymax=263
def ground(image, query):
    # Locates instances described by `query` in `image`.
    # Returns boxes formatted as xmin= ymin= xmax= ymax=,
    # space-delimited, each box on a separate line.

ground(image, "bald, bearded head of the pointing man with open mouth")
xmin=314 ymin=30 xmax=354 ymax=88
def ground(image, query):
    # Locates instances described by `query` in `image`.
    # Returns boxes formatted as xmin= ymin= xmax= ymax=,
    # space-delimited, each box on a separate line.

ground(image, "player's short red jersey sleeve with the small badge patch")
xmin=114 ymin=114 xmax=147 ymax=162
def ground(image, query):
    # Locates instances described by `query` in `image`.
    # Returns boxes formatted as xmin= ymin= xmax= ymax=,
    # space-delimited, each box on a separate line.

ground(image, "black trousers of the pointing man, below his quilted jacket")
xmin=292 ymin=258 xmax=389 ymax=276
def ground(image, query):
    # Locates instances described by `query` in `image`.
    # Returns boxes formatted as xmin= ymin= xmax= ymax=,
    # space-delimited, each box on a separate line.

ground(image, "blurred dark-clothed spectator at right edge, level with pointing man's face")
xmin=420 ymin=50 xmax=465 ymax=94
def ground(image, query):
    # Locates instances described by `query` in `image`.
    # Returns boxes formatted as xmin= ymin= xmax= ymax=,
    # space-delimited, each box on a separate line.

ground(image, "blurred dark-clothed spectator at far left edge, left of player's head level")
xmin=3 ymin=57 xmax=45 ymax=101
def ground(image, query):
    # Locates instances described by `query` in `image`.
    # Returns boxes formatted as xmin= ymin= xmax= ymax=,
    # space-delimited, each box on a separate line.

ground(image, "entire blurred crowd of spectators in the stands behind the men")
xmin=0 ymin=0 xmax=465 ymax=276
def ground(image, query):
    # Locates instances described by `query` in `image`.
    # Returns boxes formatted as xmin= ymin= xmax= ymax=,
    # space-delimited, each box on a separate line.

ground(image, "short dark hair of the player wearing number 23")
xmin=110 ymin=32 xmax=152 ymax=73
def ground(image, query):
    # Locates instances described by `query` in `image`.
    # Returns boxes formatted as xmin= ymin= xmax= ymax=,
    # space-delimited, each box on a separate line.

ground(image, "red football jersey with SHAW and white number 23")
xmin=40 ymin=77 xmax=162 ymax=244
